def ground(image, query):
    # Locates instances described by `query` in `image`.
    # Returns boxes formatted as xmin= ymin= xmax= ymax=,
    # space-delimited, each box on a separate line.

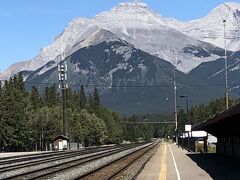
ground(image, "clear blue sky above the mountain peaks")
xmin=0 ymin=0 xmax=240 ymax=71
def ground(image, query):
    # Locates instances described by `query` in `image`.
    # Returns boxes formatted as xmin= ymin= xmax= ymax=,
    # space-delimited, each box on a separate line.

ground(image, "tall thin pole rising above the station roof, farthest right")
xmin=223 ymin=20 xmax=229 ymax=109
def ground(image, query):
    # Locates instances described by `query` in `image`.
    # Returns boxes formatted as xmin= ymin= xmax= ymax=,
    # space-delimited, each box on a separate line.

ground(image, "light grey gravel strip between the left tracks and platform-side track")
xmin=49 ymin=144 xmax=153 ymax=180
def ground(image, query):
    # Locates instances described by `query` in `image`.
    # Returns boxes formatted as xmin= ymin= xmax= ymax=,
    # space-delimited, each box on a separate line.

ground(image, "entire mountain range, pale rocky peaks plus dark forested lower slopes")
xmin=0 ymin=2 xmax=240 ymax=113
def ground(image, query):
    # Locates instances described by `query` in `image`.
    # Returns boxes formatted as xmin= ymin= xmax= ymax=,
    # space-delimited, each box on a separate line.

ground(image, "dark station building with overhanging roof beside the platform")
xmin=193 ymin=104 xmax=240 ymax=158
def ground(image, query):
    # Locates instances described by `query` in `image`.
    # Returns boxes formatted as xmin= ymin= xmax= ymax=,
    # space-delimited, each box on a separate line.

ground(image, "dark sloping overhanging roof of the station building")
xmin=192 ymin=104 xmax=240 ymax=137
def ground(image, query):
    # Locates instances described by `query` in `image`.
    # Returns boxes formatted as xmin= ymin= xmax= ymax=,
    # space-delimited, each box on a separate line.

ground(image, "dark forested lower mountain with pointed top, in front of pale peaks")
xmin=26 ymin=29 xmax=223 ymax=114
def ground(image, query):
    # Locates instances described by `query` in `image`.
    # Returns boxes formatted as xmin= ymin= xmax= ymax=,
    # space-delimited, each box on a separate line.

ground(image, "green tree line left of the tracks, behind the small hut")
xmin=0 ymin=73 xmax=153 ymax=151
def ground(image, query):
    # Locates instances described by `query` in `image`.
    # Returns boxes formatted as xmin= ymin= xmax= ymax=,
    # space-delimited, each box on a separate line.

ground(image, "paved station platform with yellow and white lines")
xmin=137 ymin=143 xmax=213 ymax=180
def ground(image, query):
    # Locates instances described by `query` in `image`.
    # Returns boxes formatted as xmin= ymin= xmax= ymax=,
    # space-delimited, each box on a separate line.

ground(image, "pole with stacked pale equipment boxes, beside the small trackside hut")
xmin=58 ymin=52 xmax=68 ymax=136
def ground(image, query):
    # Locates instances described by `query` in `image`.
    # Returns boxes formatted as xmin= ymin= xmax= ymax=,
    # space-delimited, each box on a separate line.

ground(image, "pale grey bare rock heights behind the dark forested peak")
xmin=0 ymin=2 xmax=239 ymax=79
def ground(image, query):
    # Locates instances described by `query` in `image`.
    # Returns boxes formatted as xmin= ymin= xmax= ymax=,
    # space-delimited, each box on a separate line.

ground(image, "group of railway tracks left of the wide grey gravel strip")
xmin=0 ymin=144 xmax=149 ymax=179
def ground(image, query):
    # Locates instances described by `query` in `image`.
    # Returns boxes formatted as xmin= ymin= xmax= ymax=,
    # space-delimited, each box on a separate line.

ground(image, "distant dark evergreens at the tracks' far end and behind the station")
xmin=139 ymin=98 xmax=240 ymax=138
